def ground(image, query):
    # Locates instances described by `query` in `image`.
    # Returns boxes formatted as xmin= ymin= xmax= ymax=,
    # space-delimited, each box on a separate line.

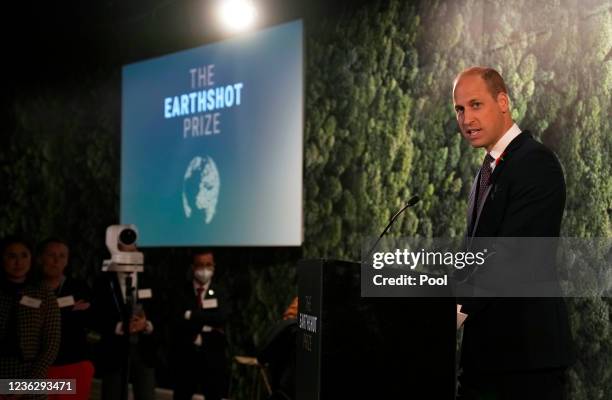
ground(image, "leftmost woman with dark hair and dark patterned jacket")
xmin=0 ymin=237 xmax=60 ymax=386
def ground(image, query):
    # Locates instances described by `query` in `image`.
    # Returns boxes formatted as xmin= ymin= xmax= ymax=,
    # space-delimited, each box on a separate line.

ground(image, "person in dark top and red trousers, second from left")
xmin=37 ymin=238 xmax=94 ymax=400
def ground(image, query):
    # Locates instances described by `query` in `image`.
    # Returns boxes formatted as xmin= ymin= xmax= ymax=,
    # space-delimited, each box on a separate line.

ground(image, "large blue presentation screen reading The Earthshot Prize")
xmin=121 ymin=21 xmax=303 ymax=246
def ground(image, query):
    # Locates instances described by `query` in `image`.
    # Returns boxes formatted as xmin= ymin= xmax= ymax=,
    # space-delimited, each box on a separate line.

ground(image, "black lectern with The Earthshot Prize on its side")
xmin=296 ymin=260 xmax=456 ymax=400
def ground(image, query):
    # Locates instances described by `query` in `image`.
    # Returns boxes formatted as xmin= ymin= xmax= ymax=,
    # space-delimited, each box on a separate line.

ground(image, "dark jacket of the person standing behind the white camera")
xmin=91 ymin=272 xmax=160 ymax=372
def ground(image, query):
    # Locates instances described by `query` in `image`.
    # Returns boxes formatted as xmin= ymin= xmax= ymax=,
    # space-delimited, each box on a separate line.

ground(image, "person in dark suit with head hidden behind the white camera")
xmin=92 ymin=244 xmax=159 ymax=400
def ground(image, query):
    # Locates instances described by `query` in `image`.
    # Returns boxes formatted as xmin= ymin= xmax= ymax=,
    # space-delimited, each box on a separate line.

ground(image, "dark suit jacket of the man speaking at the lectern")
xmin=460 ymin=131 xmax=573 ymax=373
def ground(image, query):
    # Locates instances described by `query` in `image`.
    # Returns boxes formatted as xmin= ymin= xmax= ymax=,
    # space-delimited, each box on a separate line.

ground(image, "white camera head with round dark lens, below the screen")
xmin=102 ymin=224 xmax=144 ymax=272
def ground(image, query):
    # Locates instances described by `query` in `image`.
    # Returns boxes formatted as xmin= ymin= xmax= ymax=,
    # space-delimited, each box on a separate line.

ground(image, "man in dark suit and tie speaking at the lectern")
xmin=453 ymin=67 xmax=573 ymax=400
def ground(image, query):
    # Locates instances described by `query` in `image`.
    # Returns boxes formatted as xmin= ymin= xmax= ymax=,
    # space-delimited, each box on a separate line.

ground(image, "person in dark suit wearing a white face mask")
xmin=173 ymin=249 xmax=229 ymax=400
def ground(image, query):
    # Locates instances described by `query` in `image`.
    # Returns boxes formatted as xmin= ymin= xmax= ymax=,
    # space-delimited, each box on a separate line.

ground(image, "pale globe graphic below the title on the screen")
xmin=183 ymin=156 xmax=221 ymax=224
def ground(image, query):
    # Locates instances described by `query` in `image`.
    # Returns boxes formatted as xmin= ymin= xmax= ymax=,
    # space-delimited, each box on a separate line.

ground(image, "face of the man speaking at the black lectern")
xmin=453 ymin=75 xmax=509 ymax=151
